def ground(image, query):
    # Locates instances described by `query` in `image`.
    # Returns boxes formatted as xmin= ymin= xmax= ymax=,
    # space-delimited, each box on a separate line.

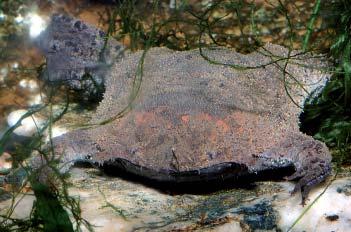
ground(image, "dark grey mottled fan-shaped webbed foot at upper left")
xmin=36 ymin=14 xmax=124 ymax=98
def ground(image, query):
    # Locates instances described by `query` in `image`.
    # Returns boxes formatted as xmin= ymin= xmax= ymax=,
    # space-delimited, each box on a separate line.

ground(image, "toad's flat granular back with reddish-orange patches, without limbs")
xmin=74 ymin=46 xmax=328 ymax=171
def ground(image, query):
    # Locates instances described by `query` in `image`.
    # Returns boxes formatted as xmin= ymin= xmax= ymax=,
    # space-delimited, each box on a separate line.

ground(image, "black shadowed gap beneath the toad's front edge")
xmin=82 ymin=159 xmax=295 ymax=194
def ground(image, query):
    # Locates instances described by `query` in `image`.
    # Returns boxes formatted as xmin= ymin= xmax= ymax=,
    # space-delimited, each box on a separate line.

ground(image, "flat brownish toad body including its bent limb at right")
xmin=54 ymin=45 xmax=331 ymax=203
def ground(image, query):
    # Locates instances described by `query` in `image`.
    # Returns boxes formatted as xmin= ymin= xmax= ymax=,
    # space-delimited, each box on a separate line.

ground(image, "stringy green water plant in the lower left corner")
xmin=0 ymin=79 xmax=92 ymax=231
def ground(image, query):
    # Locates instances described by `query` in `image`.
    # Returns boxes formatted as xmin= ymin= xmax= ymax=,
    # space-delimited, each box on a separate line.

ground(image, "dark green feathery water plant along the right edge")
xmin=301 ymin=0 xmax=351 ymax=163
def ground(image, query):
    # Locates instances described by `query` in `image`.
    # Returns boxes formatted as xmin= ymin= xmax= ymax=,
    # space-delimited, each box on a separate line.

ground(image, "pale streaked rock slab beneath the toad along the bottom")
xmin=0 ymin=168 xmax=351 ymax=232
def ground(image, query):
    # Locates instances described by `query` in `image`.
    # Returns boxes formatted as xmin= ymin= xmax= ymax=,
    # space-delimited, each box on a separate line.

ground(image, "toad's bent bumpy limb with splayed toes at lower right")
xmin=254 ymin=133 xmax=331 ymax=205
